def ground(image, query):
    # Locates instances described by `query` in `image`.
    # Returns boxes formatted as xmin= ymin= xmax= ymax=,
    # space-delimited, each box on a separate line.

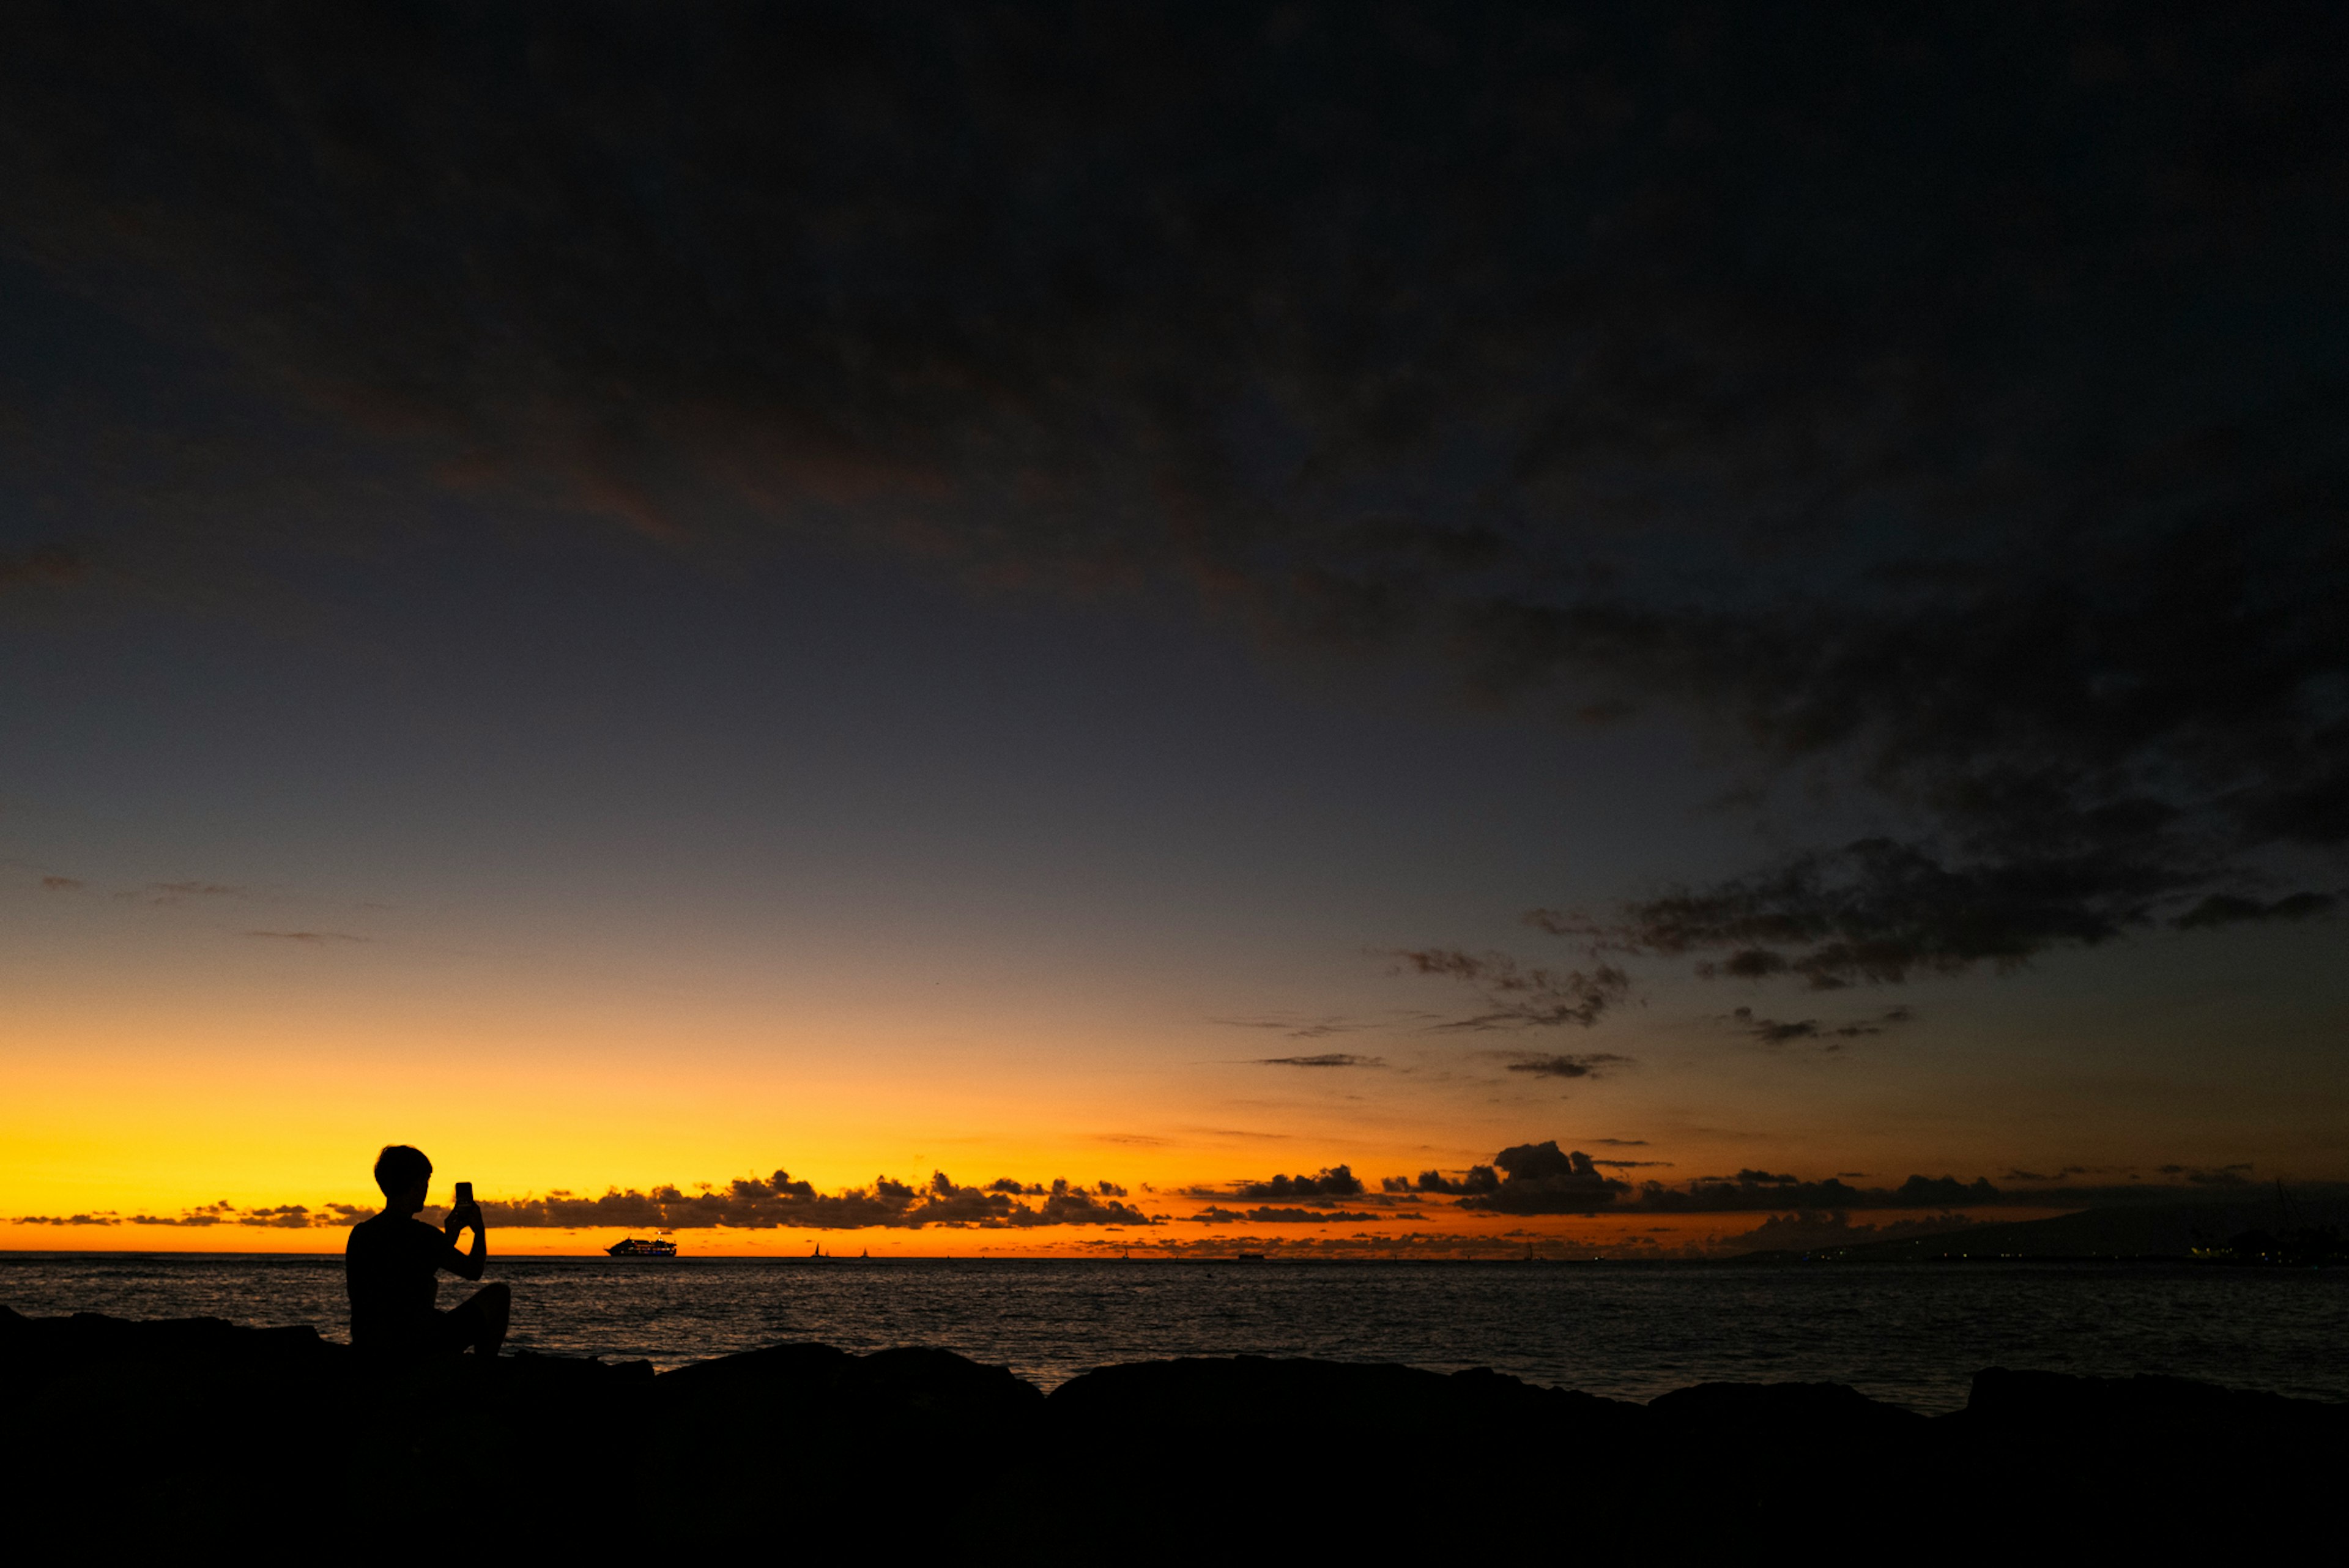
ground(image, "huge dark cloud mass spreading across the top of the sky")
xmin=0 ymin=2 xmax=2349 ymax=1006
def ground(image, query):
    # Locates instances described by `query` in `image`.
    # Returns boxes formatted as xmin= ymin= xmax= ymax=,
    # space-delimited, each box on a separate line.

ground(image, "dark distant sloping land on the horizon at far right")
xmin=1736 ymin=1187 xmax=2349 ymax=1262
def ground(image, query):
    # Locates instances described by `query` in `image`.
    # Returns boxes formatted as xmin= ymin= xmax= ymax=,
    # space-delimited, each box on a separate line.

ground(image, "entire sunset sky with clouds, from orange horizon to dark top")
xmin=0 ymin=5 xmax=2349 ymax=1255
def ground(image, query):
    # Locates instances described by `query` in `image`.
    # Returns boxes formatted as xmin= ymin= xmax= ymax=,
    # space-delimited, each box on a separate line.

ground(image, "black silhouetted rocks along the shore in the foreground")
xmin=0 ymin=1309 xmax=2349 ymax=1561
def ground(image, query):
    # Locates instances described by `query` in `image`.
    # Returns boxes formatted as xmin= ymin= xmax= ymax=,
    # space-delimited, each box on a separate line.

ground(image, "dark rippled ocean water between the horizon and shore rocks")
xmin=0 ymin=1253 xmax=2349 ymax=1413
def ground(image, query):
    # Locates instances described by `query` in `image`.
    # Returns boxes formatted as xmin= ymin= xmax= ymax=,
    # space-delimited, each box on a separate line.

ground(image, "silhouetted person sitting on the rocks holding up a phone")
xmin=343 ymin=1142 xmax=512 ymax=1356
